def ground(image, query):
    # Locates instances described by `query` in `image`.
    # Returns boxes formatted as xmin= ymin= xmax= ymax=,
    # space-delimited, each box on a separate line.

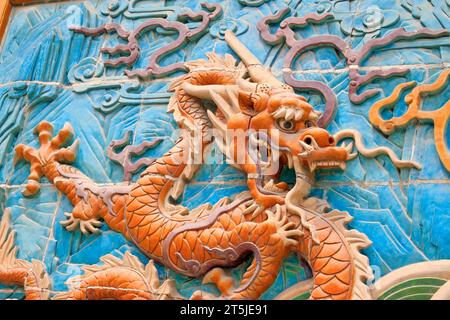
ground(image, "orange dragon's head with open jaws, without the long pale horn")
xmin=209 ymin=88 xmax=354 ymax=206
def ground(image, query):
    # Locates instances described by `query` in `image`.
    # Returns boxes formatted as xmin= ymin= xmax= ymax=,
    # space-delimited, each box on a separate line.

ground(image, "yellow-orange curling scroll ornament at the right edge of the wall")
xmin=369 ymin=69 xmax=450 ymax=172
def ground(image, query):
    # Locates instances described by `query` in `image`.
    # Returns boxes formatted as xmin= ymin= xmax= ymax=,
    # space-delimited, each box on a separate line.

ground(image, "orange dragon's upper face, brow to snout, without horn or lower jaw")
xmin=239 ymin=89 xmax=351 ymax=172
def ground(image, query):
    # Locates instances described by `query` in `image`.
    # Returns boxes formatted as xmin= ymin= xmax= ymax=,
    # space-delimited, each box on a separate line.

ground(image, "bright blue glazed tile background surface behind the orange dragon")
xmin=0 ymin=0 xmax=450 ymax=299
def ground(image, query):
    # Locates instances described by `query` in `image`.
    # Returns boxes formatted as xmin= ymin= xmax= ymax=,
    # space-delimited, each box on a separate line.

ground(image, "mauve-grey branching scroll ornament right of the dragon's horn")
xmin=258 ymin=8 xmax=450 ymax=108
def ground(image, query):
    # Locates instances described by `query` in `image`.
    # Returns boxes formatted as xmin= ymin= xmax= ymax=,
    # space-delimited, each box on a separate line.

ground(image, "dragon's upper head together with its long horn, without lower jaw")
xmin=222 ymin=32 xmax=354 ymax=182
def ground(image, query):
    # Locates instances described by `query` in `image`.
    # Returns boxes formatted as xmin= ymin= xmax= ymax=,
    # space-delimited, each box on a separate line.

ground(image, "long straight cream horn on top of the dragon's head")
xmin=225 ymin=30 xmax=284 ymax=88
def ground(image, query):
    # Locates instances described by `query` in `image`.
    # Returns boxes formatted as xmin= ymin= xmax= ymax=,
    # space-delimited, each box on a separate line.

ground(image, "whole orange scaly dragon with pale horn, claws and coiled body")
xmin=0 ymin=32 xmax=417 ymax=299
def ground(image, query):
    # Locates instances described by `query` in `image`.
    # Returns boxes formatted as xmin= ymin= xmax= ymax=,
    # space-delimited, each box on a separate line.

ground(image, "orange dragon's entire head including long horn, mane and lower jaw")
xmin=181 ymin=32 xmax=354 ymax=207
